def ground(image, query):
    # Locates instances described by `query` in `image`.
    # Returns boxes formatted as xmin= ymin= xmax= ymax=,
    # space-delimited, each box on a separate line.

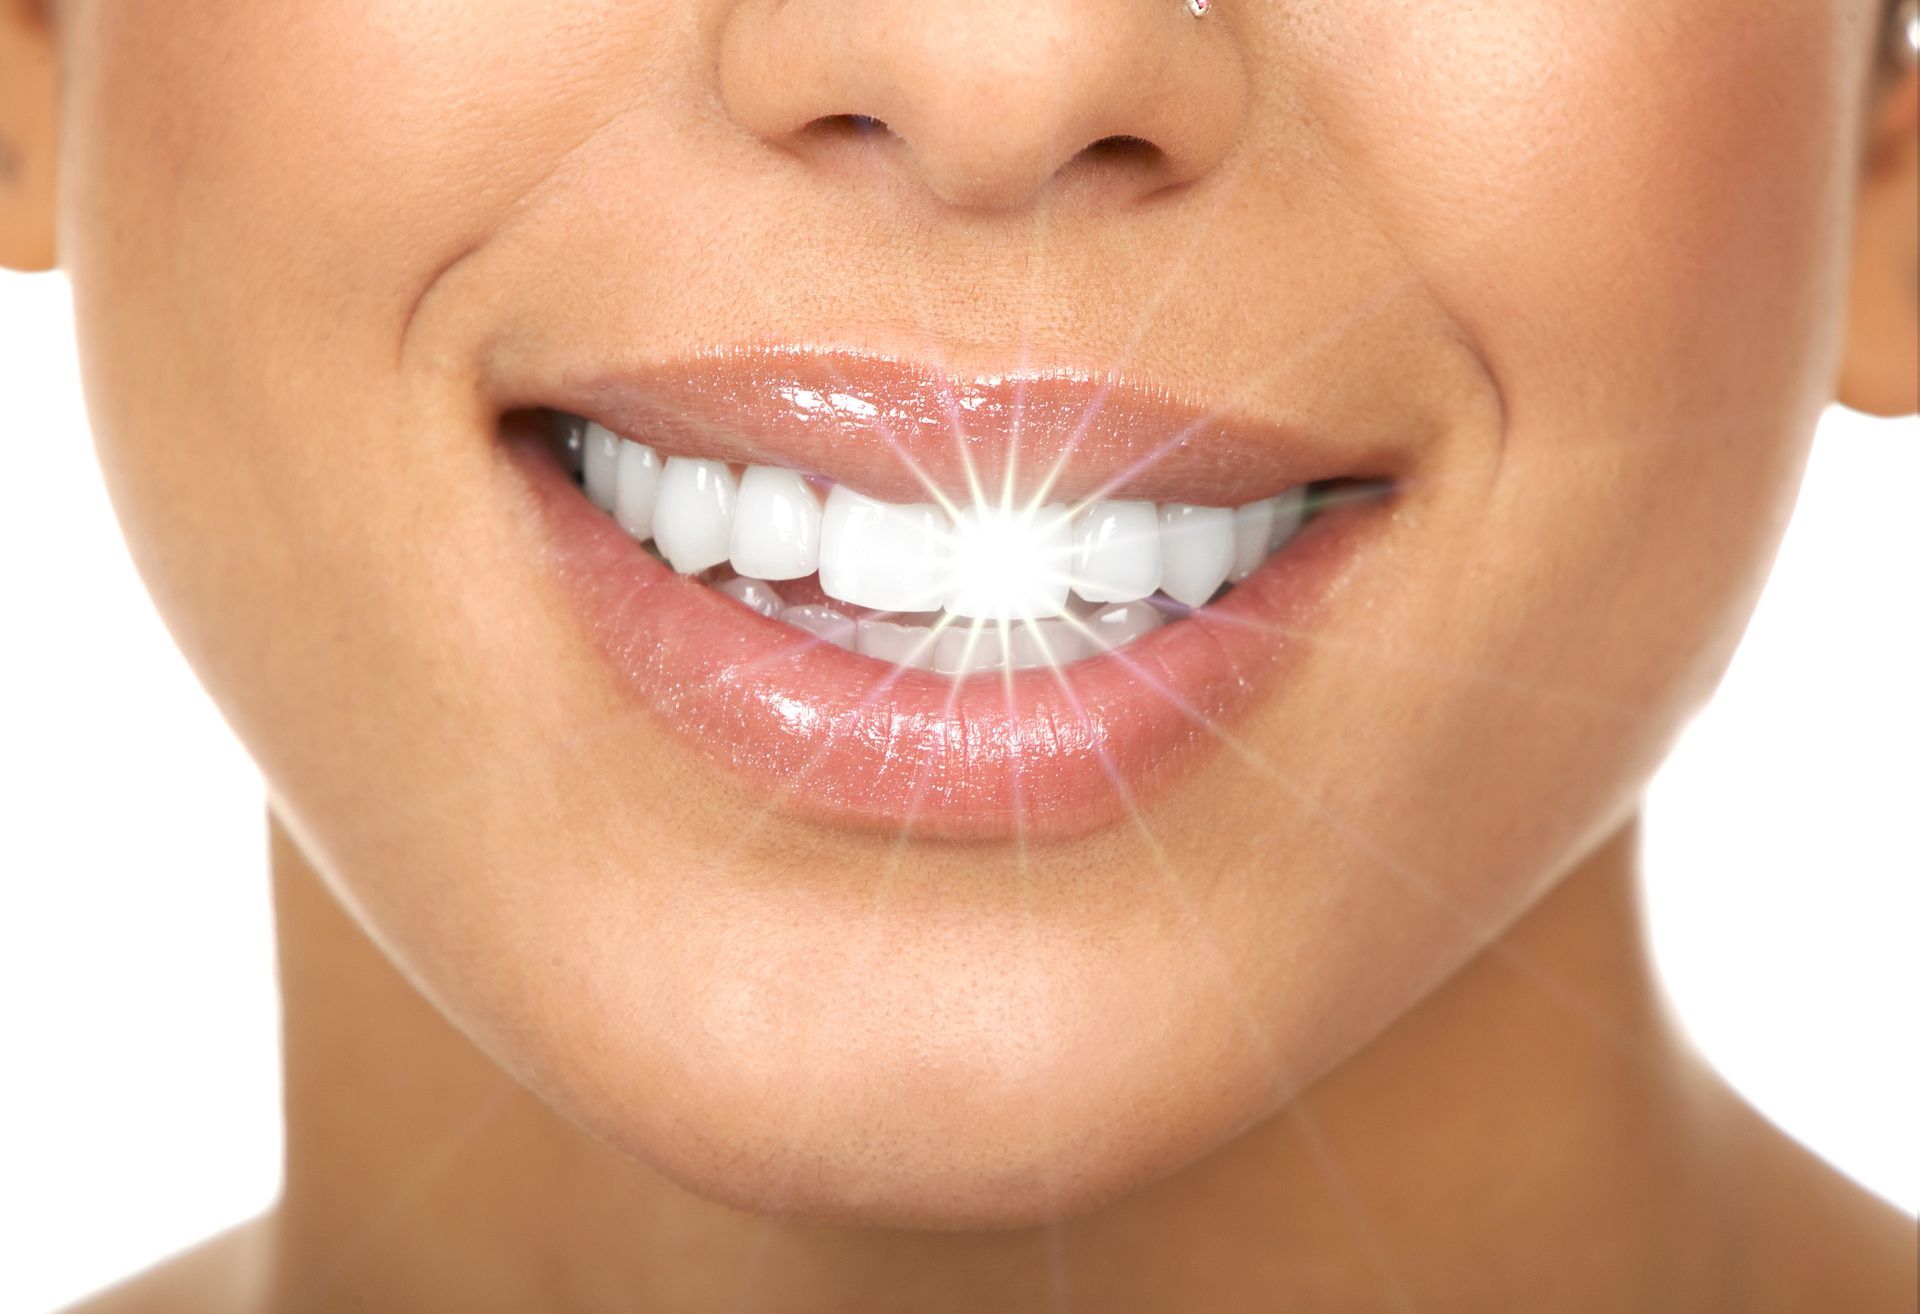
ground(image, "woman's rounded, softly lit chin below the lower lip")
xmin=426 ymin=841 xmax=1363 ymax=1231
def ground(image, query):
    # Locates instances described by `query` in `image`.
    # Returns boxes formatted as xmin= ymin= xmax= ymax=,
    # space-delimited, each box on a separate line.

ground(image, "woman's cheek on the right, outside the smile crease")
xmin=1306 ymin=0 xmax=1864 ymax=715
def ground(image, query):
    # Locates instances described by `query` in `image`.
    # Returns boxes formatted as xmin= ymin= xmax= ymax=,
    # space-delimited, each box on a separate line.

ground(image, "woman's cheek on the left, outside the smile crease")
xmin=61 ymin=0 xmax=693 ymax=760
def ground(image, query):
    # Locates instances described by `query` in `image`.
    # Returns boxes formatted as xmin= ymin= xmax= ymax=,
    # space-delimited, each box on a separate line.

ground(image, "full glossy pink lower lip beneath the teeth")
xmin=507 ymin=434 xmax=1382 ymax=840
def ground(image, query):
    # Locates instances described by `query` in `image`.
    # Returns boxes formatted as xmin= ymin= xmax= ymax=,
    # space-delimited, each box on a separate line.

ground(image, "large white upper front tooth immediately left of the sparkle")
xmin=820 ymin=484 xmax=947 ymax=611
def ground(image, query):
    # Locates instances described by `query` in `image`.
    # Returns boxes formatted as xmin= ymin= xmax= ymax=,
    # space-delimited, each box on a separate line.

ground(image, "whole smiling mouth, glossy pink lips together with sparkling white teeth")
xmin=497 ymin=350 xmax=1394 ymax=840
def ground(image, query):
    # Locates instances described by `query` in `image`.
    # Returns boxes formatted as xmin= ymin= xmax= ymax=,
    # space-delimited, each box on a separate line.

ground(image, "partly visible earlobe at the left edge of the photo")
xmin=0 ymin=0 xmax=56 ymax=269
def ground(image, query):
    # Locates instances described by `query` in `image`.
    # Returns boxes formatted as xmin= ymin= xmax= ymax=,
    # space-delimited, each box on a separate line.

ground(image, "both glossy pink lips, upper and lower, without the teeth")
xmin=509 ymin=353 xmax=1380 ymax=840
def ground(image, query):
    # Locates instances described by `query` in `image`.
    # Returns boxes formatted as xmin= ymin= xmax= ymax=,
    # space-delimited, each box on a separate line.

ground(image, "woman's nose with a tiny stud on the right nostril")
xmin=718 ymin=0 xmax=1248 ymax=209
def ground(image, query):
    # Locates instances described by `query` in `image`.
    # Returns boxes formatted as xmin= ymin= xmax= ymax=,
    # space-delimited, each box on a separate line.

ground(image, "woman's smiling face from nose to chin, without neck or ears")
xmin=37 ymin=0 xmax=1880 ymax=1226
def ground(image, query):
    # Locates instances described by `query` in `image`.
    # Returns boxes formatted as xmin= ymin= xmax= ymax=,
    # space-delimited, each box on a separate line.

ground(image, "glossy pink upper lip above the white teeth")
xmin=503 ymin=348 xmax=1400 ymax=505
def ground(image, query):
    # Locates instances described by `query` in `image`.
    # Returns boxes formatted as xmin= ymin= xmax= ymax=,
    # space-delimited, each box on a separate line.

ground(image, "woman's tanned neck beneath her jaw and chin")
xmin=259 ymin=824 xmax=1720 ymax=1314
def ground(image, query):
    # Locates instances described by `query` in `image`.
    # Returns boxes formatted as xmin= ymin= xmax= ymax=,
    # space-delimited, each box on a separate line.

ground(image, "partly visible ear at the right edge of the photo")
xmin=1839 ymin=61 xmax=1920 ymax=415
